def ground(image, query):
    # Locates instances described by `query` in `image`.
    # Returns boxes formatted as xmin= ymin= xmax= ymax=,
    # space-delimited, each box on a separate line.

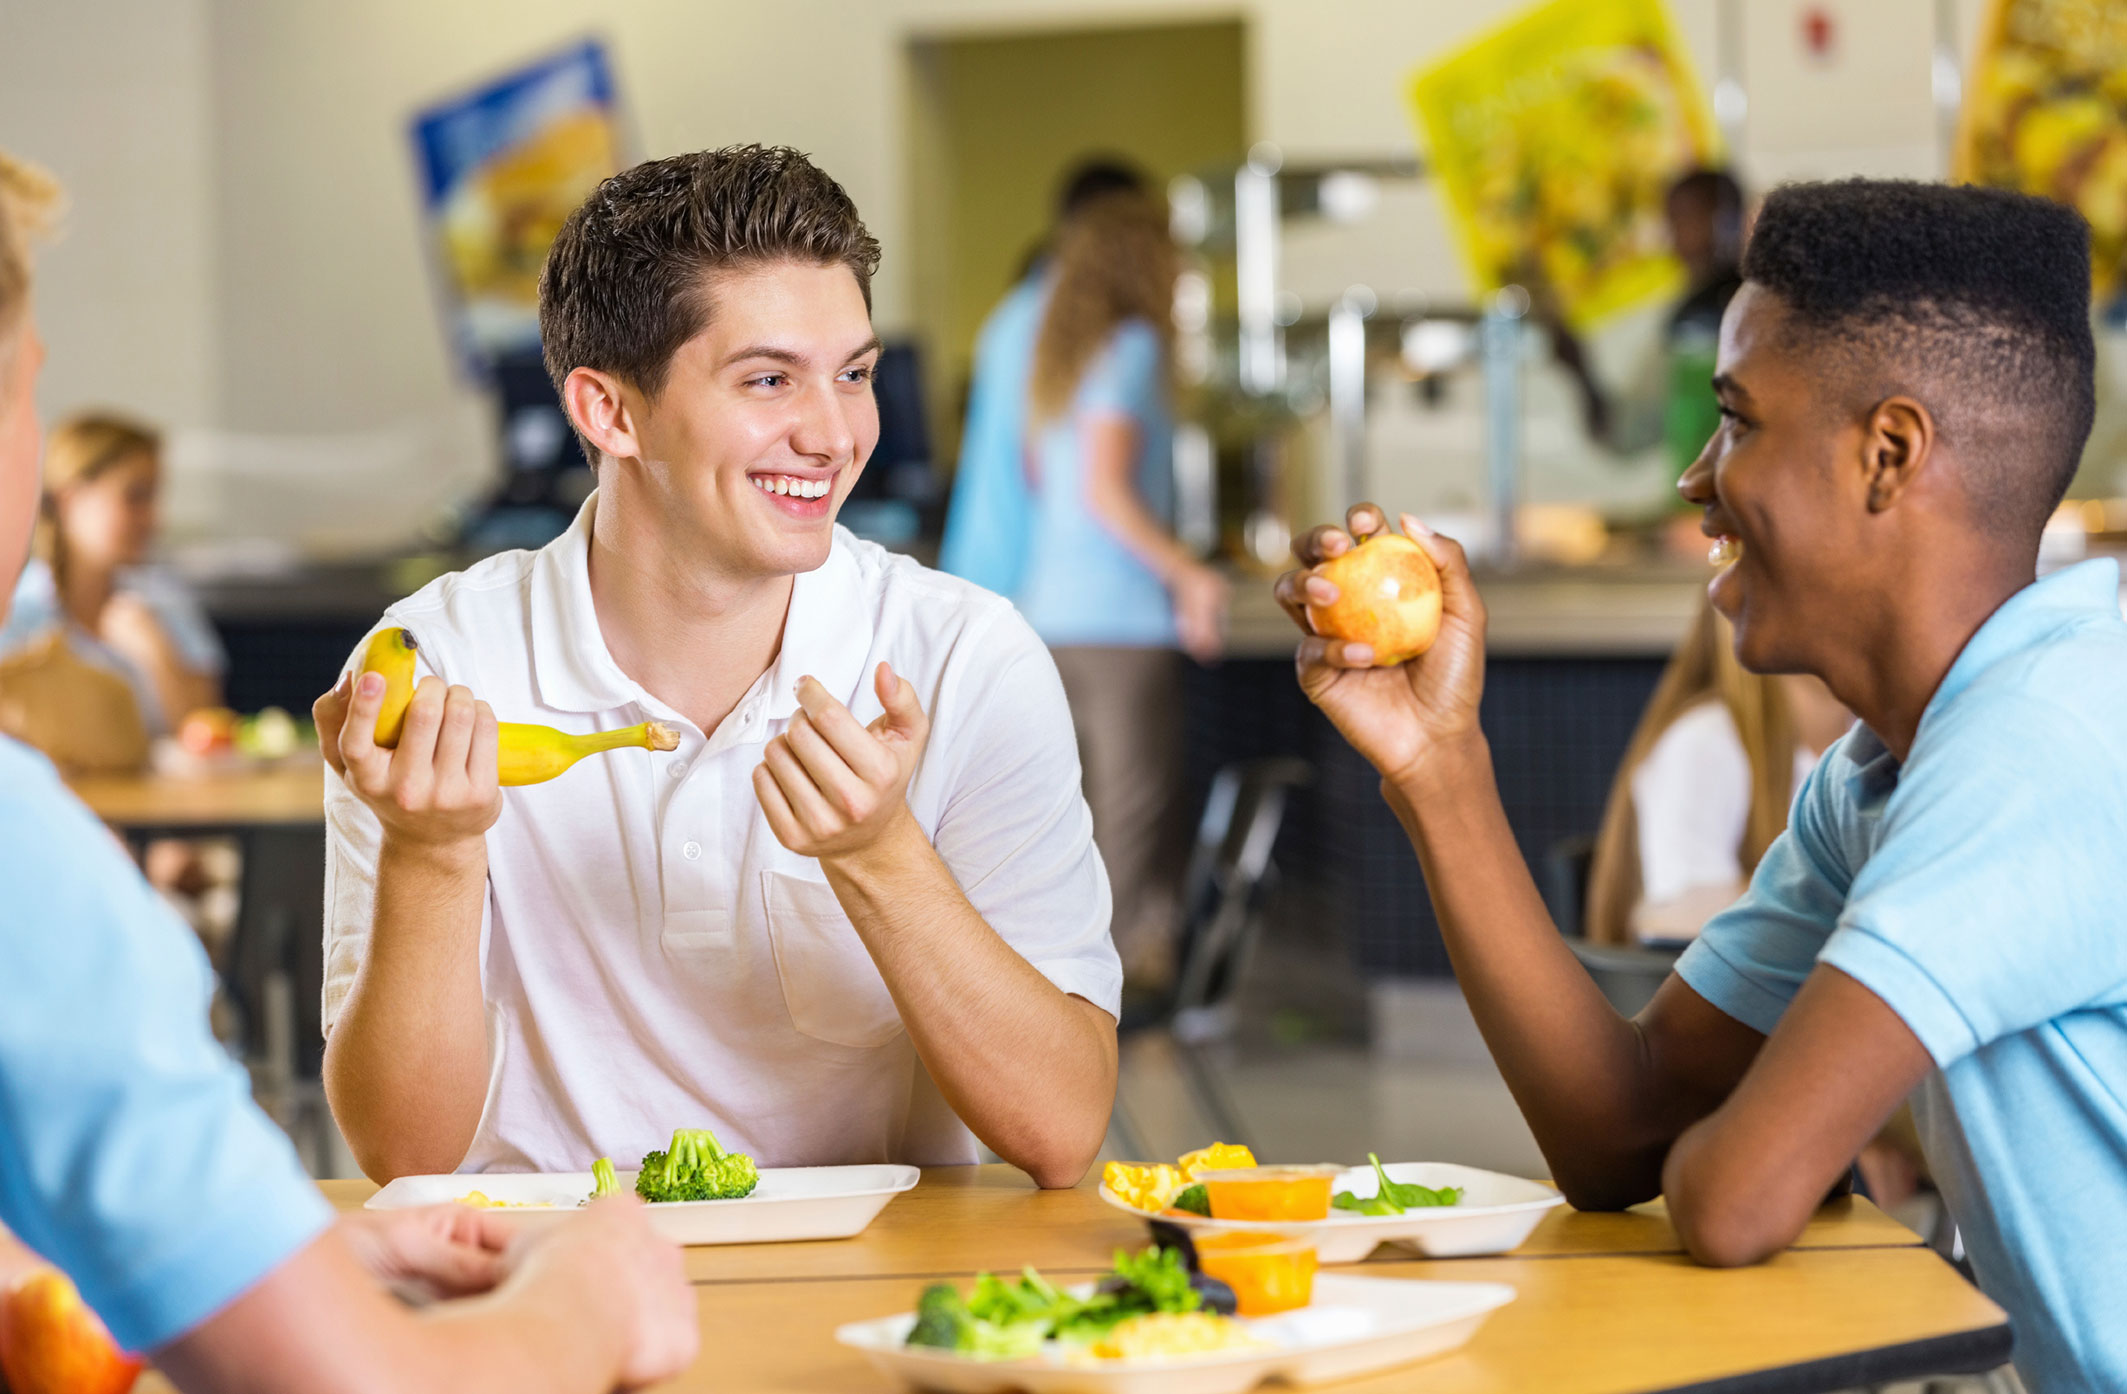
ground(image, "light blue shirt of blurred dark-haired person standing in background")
xmin=938 ymin=272 xmax=1049 ymax=596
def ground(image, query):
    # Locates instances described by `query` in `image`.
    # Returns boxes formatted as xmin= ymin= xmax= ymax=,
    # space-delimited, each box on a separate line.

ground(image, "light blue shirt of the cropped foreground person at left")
xmin=0 ymin=739 xmax=332 ymax=1351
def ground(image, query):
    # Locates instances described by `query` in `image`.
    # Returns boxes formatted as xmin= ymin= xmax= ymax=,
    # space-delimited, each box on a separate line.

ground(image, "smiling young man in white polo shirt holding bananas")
xmin=317 ymin=147 xmax=1121 ymax=1185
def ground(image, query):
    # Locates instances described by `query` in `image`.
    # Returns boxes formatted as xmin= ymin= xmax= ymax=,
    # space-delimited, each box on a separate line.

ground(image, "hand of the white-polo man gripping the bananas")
xmin=311 ymin=673 xmax=502 ymax=847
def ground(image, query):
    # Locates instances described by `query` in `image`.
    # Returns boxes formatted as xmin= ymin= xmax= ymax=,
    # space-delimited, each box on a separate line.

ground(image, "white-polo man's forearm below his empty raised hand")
xmin=821 ymin=819 xmax=1117 ymax=1188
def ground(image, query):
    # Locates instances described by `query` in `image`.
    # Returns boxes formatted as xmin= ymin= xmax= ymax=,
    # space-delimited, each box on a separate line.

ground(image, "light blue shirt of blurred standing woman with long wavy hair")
xmin=1012 ymin=319 xmax=1176 ymax=649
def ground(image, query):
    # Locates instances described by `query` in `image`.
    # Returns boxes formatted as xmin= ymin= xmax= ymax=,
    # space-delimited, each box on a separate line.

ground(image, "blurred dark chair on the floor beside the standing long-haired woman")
xmin=1112 ymin=758 xmax=1314 ymax=1156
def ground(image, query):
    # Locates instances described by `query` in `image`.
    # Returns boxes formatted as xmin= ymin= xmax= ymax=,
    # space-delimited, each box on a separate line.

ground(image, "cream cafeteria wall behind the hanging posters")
xmin=0 ymin=0 xmax=2007 ymax=512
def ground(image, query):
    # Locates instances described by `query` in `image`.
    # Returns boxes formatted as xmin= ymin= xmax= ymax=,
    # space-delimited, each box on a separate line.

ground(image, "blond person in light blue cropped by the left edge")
xmin=0 ymin=153 xmax=698 ymax=1394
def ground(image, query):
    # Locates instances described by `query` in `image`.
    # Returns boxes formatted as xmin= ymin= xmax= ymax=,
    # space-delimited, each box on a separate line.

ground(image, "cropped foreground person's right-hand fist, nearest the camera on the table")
xmin=504 ymin=1196 xmax=702 ymax=1390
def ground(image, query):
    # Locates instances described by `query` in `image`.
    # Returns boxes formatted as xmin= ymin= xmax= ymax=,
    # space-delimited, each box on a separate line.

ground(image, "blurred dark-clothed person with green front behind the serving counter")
xmin=1548 ymin=168 xmax=1746 ymax=487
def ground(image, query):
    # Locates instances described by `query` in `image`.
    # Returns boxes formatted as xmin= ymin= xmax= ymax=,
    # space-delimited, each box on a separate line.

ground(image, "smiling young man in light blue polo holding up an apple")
xmin=1278 ymin=181 xmax=2127 ymax=1392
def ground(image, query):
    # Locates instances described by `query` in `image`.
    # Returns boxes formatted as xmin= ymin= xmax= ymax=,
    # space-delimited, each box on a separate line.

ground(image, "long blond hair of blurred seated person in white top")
xmin=1582 ymin=602 xmax=1799 ymax=945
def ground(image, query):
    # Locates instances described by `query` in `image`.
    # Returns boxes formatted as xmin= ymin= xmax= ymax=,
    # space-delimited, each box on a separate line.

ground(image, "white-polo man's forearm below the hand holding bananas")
xmin=325 ymin=839 xmax=487 ymax=1181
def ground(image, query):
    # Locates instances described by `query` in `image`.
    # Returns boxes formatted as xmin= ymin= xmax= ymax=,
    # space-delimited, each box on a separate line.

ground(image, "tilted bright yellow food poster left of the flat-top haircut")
xmin=1410 ymin=0 xmax=1719 ymax=328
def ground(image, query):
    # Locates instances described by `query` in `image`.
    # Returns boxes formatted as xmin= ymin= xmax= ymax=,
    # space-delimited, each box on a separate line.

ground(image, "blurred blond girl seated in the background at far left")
xmin=0 ymin=413 xmax=228 ymax=749
